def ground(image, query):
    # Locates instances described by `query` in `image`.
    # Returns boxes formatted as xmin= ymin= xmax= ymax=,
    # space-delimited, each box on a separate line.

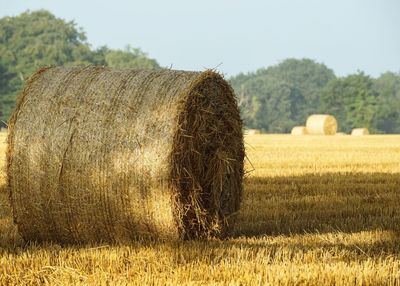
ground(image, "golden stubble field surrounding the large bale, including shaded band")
xmin=0 ymin=133 xmax=400 ymax=285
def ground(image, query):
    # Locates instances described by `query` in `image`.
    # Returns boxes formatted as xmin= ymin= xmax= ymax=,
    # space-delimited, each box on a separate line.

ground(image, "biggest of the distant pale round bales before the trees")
xmin=306 ymin=114 xmax=337 ymax=135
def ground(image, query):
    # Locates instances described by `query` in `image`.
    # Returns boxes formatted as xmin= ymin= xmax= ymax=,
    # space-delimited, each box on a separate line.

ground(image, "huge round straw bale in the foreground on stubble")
xmin=7 ymin=67 xmax=244 ymax=243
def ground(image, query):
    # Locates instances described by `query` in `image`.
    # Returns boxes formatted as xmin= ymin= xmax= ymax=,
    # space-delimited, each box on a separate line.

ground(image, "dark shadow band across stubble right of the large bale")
xmin=234 ymin=173 xmax=400 ymax=237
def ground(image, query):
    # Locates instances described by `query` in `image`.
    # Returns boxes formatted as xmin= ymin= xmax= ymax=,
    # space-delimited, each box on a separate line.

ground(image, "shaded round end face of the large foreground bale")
xmin=171 ymin=72 xmax=244 ymax=238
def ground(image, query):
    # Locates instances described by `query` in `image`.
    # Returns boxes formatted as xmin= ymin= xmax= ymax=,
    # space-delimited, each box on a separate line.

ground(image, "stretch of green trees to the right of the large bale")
xmin=230 ymin=59 xmax=400 ymax=133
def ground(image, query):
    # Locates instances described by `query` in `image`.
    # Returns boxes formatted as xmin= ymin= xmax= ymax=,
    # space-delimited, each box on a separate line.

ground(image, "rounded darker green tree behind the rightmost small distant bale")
xmin=321 ymin=72 xmax=378 ymax=132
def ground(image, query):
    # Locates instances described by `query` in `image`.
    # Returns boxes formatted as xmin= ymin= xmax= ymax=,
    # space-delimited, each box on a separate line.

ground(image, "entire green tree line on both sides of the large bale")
xmin=0 ymin=10 xmax=400 ymax=133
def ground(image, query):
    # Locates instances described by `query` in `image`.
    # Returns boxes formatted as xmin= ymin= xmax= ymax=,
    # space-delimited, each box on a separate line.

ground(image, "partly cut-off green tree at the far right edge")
xmin=373 ymin=72 xmax=400 ymax=133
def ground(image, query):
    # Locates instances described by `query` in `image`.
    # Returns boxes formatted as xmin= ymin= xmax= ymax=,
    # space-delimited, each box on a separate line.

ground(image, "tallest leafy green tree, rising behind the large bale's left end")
xmin=0 ymin=10 xmax=92 ymax=76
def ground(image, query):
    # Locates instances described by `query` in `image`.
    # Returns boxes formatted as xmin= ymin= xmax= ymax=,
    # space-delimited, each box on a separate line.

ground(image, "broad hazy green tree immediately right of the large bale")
xmin=230 ymin=59 xmax=335 ymax=132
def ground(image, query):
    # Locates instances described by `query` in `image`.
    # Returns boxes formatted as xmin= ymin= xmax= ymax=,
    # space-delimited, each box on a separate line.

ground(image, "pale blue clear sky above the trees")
xmin=0 ymin=0 xmax=400 ymax=77
